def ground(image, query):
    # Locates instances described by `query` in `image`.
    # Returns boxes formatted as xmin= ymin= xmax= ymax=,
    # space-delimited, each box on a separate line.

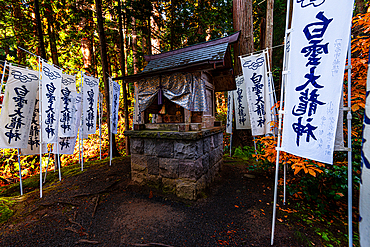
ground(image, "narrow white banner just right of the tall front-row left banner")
xmin=58 ymin=74 xmax=77 ymax=137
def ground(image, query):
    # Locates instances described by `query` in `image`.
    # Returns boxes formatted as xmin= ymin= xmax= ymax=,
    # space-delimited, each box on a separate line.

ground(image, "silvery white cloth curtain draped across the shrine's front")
xmin=138 ymin=73 xmax=207 ymax=112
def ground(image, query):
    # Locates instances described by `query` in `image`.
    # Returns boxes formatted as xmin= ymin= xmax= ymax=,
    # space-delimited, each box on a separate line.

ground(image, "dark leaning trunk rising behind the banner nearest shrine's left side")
xmin=95 ymin=0 xmax=120 ymax=157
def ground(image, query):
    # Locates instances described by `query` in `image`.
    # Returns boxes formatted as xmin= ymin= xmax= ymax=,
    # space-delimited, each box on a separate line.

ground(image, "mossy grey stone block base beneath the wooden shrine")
xmin=125 ymin=127 xmax=224 ymax=200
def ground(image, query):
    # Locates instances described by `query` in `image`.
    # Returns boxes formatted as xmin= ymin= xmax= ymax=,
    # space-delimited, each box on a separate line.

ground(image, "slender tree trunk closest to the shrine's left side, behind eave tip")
xmin=118 ymin=0 xmax=131 ymax=155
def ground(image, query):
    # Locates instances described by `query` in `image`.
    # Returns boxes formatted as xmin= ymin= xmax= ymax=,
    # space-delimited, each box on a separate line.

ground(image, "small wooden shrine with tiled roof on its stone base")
xmin=117 ymin=32 xmax=239 ymax=200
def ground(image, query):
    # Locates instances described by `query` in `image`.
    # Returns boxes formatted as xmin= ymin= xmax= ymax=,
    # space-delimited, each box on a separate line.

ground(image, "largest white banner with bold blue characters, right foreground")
xmin=282 ymin=0 xmax=354 ymax=164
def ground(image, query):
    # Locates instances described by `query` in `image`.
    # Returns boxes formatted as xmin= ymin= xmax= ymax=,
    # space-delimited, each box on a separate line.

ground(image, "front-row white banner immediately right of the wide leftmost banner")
xmin=41 ymin=62 xmax=62 ymax=143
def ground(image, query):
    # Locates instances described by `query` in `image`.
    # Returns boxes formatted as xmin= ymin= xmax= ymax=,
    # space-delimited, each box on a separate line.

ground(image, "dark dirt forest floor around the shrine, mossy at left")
xmin=0 ymin=157 xmax=346 ymax=246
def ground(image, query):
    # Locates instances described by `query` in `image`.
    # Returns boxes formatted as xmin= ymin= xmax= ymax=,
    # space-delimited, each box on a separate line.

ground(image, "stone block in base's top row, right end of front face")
xmin=174 ymin=140 xmax=203 ymax=159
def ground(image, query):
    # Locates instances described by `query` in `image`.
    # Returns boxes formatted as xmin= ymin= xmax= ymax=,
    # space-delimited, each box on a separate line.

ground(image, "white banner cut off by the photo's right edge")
xmin=359 ymin=58 xmax=370 ymax=246
